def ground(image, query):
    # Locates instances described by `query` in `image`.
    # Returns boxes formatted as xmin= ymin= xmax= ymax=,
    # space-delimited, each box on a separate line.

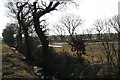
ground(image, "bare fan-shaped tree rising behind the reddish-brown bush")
xmin=61 ymin=14 xmax=82 ymax=39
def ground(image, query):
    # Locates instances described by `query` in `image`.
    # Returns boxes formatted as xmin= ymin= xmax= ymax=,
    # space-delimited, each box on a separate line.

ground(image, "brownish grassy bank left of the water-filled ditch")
xmin=2 ymin=43 xmax=37 ymax=78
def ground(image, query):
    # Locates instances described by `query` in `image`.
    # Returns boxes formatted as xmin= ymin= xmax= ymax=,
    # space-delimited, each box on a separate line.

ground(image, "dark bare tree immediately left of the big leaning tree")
xmin=16 ymin=2 xmax=32 ymax=60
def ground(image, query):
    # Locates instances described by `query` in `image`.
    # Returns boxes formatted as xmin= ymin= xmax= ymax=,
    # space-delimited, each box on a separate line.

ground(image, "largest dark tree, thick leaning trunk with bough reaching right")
xmin=33 ymin=2 xmax=60 ymax=55
